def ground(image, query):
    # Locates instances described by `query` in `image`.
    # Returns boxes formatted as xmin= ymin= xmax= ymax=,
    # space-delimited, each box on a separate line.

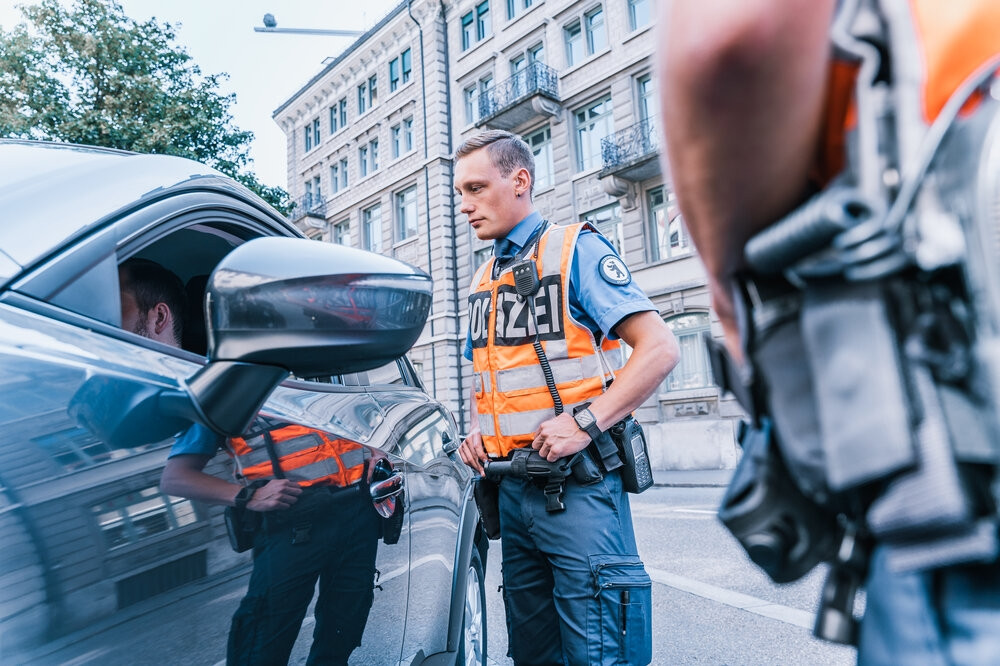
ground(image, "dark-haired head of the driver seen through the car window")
xmin=118 ymin=258 xmax=185 ymax=347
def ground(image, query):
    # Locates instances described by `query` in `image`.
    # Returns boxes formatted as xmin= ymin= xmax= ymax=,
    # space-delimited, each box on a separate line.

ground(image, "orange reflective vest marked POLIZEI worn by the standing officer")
xmin=469 ymin=224 xmax=621 ymax=457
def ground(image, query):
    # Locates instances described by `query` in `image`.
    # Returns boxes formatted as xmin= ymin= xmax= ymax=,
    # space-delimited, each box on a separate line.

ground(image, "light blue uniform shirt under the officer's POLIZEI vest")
xmin=463 ymin=211 xmax=656 ymax=361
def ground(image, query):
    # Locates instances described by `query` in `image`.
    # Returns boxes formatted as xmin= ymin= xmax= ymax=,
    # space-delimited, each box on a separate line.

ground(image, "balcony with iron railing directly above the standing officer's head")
xmin=476 ymin=62 xmax=562 ymax=130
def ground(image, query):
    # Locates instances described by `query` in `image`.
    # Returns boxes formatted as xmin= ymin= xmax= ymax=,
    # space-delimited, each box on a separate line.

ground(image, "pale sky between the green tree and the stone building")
xmin=0 ymin=0 xmax=399 ymax=189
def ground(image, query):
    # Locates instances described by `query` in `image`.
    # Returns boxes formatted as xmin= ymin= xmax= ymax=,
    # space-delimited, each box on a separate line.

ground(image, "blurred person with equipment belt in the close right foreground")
xmin=658 ymin=0 xmax=1000 ymax=664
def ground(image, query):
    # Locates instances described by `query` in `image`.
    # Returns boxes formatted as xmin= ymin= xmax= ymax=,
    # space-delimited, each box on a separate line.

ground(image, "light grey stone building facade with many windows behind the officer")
xmin=274 ymin=0 xmax=740 ymax=469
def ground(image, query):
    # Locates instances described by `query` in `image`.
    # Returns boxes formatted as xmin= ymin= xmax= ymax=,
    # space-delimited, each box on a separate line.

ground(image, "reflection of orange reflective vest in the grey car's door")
xmin=229 ymin=424 xmax=368 ymax=487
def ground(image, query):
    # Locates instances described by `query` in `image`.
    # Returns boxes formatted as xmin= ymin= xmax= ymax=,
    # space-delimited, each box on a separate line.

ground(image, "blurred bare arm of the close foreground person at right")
xmin=658 ymin=0 xmax=836 ymax=353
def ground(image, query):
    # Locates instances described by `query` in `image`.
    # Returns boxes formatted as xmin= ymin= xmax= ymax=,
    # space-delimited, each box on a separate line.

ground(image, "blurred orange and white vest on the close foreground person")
xmin=813 ymin=0 xmax=1000 ymax=186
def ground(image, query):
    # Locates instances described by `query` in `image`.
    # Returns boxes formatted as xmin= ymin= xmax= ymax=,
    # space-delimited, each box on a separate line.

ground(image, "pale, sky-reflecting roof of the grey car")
xmin=0 ymin=139 xmax=288 ymax=279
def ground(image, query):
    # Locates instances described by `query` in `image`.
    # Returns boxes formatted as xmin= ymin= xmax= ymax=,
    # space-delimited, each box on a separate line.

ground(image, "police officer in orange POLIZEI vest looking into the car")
xmin=455 ymin=131 xmax=678 ymax=664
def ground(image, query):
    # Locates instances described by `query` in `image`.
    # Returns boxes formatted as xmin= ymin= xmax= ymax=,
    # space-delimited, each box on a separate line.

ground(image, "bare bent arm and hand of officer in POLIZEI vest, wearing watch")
xmin=532 ymin=311 xmax=680 ymax=461
